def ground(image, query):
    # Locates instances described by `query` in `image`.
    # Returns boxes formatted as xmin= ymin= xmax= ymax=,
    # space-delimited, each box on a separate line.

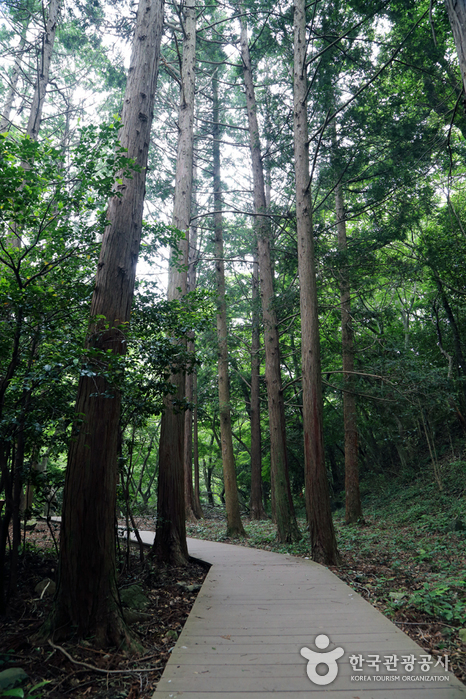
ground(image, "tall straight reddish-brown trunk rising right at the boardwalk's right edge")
xmin=293 ymin=0 xmax=340 ymax=565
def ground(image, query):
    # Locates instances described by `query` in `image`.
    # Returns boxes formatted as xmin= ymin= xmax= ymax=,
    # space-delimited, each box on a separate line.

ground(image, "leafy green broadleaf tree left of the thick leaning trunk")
xmin=0 ymin=124 xmax=135 ymax=606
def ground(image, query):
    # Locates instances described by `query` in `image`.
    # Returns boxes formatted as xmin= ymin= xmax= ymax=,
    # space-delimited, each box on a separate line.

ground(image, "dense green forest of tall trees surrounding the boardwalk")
xmin=0 ymin=0 xmax=466 ymax=699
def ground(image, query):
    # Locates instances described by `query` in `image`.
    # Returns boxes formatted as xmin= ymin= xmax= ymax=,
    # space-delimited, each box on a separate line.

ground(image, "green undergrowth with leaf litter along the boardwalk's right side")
xmin=188 ymin=460 xmax=466 ymax=681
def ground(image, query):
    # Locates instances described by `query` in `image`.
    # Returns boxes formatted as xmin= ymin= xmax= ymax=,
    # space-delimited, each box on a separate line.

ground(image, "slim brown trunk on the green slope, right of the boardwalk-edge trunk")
xmin=335 ymin=178 xmax=362 ymax=524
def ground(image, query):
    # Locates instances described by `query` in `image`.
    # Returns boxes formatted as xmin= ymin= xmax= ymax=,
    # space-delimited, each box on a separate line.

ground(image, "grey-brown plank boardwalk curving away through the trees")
xmin=143 ymin=533 xmax=466 ymax=699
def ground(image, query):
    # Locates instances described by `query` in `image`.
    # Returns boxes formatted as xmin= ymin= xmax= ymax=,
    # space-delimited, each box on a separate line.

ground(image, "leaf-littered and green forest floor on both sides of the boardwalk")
xmin=0 ymin=462 xmax=466 ymax=699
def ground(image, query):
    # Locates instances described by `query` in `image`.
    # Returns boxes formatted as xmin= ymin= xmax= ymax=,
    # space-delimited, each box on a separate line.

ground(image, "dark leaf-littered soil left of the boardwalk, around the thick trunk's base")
xmin=0 ymin=519 xmax=208 ymax=699
